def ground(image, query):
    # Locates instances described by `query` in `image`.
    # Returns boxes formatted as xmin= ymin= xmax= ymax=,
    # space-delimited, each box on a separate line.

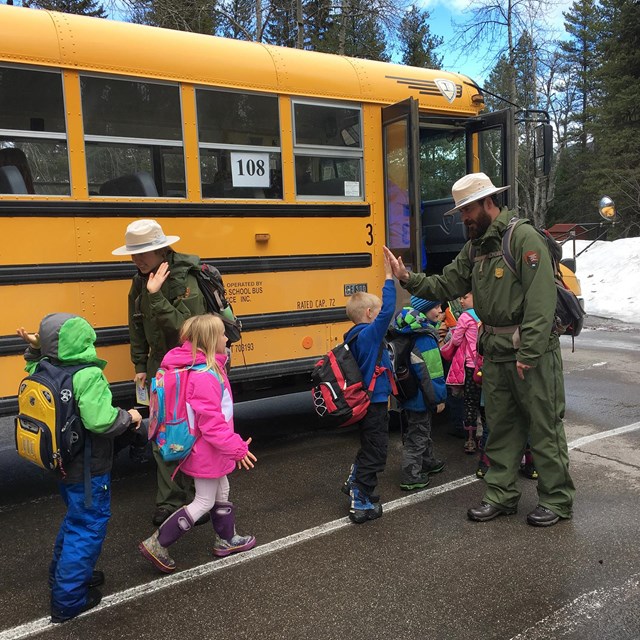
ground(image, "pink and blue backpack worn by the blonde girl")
xmin=149 ymin=364 xmax=223 ymax=462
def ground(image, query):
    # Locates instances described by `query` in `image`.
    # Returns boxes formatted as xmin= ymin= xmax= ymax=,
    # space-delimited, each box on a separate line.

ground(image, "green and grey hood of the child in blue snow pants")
xmin=40 ymin=313 xmax=107 ymax=369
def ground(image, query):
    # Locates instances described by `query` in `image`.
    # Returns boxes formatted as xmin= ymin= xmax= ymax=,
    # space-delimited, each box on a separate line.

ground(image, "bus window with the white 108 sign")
xmin=196 ymin=89 xmax=282 ymax=199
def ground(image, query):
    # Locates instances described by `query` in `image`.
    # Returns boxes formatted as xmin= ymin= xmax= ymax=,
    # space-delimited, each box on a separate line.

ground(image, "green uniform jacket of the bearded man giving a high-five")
xmin=404 ymin=207 xmax=560 ymax=366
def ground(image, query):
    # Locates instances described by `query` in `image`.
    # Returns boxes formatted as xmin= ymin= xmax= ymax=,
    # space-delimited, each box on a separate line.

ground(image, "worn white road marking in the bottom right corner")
xmin=511 ymin=574 xmax=640 ymax=640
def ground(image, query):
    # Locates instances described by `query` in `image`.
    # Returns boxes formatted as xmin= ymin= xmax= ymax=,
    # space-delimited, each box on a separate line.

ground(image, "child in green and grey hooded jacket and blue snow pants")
xmin=18 ymin=313 xmax=142 ymax=622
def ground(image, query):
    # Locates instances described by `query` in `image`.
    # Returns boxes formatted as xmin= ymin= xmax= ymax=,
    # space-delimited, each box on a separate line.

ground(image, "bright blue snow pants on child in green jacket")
xmin=49 ymin=473 xmax=111 ymax=618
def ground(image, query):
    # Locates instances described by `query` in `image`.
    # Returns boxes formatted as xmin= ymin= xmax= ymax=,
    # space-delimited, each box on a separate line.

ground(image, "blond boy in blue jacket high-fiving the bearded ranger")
xmin=342 ymin=256 xmax=396 ymax=524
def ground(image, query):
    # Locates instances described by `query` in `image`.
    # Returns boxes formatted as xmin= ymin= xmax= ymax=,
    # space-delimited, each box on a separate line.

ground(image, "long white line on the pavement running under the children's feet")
xmin=0 ymin=422 xmax=640 ymax=640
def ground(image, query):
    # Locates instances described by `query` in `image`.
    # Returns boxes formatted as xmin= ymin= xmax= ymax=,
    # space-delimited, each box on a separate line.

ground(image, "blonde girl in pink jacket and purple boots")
xmin=138 ymin=314 xmax=256 ymax=573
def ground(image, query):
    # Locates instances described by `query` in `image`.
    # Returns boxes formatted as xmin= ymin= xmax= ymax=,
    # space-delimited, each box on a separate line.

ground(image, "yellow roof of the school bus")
xmin=0 ymin=5 xmax=484 ymax=115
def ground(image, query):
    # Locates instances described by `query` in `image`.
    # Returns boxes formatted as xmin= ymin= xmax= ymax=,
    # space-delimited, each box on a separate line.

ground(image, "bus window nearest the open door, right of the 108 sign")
xmin=293 ymin=102 xmax=364 ymax=200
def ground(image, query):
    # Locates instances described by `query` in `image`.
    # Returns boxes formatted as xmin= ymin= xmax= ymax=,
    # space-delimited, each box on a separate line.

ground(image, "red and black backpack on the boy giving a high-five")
xmin=311 ymin=332 xmax=384 ymax=427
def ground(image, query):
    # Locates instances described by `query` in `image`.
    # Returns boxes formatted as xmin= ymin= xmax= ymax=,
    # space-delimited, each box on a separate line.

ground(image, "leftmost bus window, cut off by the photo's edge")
xmin=0 ymin=66 xmax=70 ymax=195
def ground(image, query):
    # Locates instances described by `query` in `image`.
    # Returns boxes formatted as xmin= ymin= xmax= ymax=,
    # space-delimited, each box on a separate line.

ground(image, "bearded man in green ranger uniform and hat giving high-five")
xmin=385 ymin=173 xmax=575 ymax=527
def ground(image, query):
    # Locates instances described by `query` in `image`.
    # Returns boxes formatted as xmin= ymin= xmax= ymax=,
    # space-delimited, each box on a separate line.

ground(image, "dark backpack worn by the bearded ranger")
xmin=469 ymin=216 xmax=585 ymax=338
